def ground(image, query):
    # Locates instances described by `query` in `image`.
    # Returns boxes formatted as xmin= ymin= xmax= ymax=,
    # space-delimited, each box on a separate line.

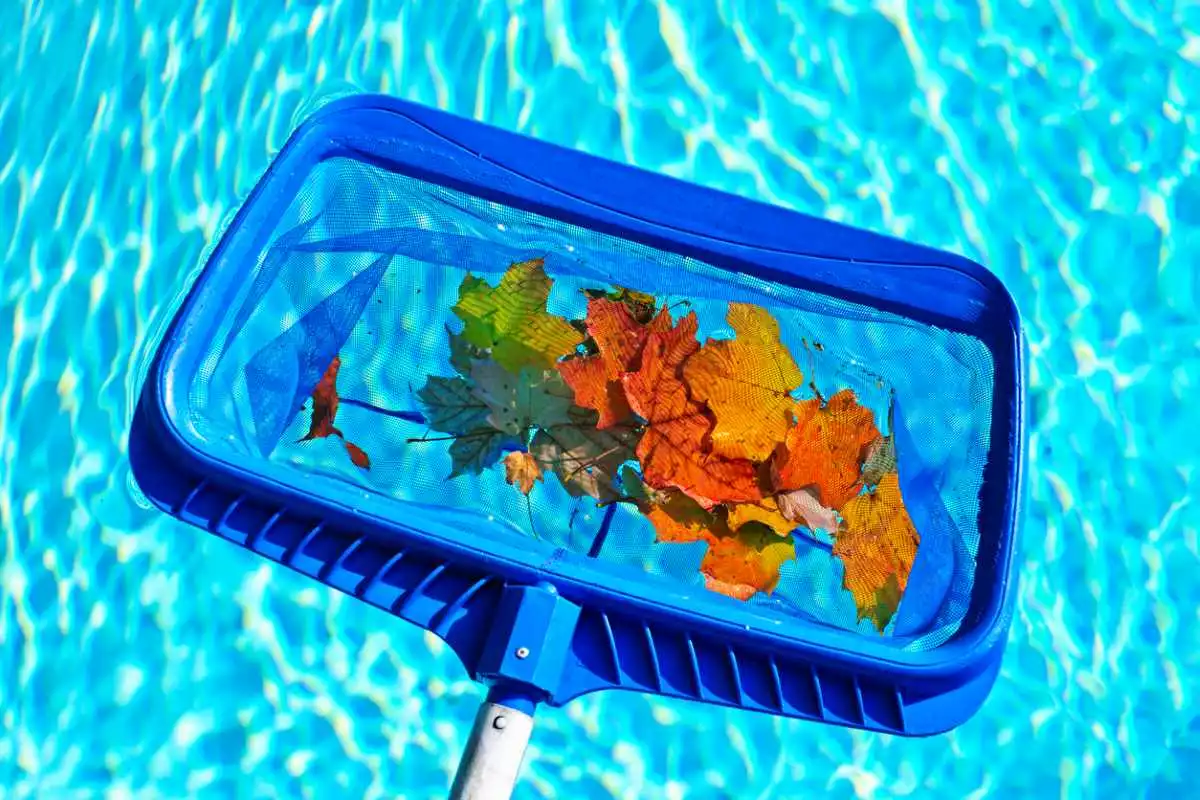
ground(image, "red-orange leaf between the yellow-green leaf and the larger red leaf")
xmin=558 ymin=295 xmax=670 ymax=428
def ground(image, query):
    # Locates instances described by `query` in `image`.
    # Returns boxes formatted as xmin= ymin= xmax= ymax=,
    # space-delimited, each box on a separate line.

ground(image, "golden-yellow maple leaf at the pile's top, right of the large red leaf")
xmin=683 ymin=302 xmax=804 ymax=461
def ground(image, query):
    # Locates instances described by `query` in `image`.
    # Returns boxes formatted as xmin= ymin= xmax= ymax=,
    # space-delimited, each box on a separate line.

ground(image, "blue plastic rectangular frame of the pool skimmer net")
xmin=130 ymin=95 xmax=1025 ymax=735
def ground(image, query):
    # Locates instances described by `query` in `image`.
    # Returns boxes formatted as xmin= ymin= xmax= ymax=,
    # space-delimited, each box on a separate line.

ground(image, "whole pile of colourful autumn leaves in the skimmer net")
xmin=302 ymin=259 xmax=919 ymax=631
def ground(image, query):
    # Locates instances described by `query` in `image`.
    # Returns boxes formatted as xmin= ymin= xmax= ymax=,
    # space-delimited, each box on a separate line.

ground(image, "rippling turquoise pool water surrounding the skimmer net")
xmin=0 ymin=0 xmax=1200 ymax=799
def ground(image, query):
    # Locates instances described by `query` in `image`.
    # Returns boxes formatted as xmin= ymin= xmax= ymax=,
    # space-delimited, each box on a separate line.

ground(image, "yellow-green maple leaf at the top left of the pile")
xmin=452 ymin=258 xmax=583 ymax=373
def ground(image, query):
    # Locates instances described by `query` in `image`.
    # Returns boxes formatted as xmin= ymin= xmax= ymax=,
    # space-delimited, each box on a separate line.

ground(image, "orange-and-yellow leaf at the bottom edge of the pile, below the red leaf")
xmin=700 ymin=523 xmax=796 ymax=600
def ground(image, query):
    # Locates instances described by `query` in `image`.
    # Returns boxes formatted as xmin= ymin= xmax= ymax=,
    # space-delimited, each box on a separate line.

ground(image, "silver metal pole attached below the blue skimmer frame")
xmin=450 ymin=694 xmax=533 ymax=800
